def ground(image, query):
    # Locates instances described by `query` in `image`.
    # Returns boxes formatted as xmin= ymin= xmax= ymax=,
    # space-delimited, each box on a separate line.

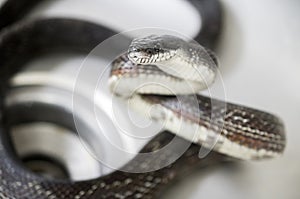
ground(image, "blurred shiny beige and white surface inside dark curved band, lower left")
xmin=12 ymin=123 xmax=102 ymax=180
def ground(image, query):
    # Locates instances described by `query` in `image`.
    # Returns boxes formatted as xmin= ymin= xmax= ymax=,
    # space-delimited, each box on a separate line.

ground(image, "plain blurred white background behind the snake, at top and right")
xmin=1 ymin=0 xmax=300 ymax=199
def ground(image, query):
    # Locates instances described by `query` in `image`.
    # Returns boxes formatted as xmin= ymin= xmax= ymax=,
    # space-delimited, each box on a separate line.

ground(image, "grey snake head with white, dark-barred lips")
xmin=128 ymin=35 xmax=179 ymax=65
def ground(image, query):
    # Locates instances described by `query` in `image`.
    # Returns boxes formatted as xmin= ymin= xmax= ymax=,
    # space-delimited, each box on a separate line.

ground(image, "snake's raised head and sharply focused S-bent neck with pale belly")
xmin=110 ymin=35 xmax=285 ymax=159
